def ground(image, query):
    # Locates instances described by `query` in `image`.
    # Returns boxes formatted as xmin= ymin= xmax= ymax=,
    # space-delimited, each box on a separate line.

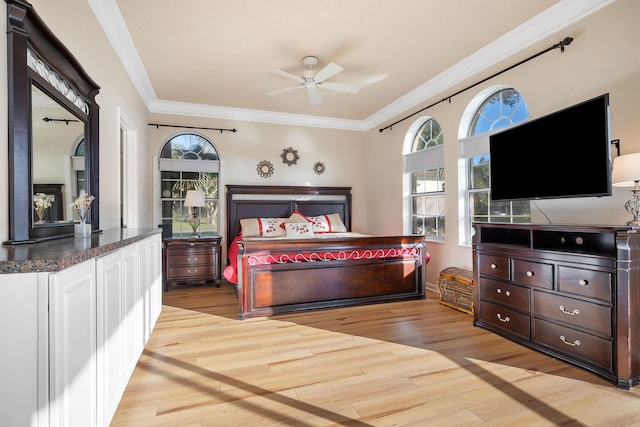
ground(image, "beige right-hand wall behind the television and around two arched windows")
xmin=366 ymin=0 xmax=640 ymax=283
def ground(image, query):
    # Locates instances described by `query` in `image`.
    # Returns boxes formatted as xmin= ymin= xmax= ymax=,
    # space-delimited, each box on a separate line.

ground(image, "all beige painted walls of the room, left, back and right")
xmin=0 ymin=0 xmax=640 ymax=283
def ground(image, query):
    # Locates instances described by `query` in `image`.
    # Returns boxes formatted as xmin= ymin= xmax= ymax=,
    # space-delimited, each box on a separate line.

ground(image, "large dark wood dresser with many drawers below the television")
xmin=473 ymin=223 xmax=640 ymax=389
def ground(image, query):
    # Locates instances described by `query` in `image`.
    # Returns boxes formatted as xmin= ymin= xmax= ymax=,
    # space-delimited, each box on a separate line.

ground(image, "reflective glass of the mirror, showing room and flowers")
xmin=31 ymin=85 xmax=86 ymax=227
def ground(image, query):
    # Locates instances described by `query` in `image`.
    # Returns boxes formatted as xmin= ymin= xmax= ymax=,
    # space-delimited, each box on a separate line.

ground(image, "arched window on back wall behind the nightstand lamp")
xmin=160 ymin=133 xmax=220 ymax=237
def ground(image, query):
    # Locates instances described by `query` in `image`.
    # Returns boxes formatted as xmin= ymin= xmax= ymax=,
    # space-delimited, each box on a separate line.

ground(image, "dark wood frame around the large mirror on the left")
xmin=5 ymin=0 xmax=100 ymax=244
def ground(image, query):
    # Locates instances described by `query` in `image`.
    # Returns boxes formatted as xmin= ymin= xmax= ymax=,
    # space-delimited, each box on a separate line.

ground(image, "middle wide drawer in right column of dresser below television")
xmin=533 ymin=291 xmax=612 ymax=337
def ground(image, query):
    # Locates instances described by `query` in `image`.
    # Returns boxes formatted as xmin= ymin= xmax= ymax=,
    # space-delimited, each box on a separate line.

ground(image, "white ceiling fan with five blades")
xmin=267 ymin=56 xmax=361 ymax=105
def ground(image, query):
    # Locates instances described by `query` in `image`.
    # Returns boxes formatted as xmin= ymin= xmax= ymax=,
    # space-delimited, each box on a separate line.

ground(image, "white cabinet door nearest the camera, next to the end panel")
xmin=49 ymin=260 xmax=97 ymax=427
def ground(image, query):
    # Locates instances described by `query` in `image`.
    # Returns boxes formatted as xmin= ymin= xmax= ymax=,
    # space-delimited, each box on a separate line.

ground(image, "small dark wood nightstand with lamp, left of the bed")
xmin=162 ymin=236 xmax=222 ymax=291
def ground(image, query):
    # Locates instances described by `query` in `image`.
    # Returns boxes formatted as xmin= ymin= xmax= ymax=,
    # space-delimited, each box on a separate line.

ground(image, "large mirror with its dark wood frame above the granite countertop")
xmin=4 ymin=0 xmax=100 ymax=244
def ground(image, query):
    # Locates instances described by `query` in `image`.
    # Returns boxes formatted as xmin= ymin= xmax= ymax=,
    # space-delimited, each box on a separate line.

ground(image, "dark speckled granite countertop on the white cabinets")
xmin=0 ymin=228 xmax=161 ymax=274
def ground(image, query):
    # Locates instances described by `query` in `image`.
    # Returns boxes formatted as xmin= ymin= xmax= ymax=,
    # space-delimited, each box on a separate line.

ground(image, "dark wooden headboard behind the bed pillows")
xmin=227 ymin=185 xmax=351 ymax=251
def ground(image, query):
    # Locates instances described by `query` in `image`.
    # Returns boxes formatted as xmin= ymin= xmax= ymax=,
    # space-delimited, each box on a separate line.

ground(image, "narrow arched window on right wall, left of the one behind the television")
xmin=403 ymin=117 xmax=445 ymax=240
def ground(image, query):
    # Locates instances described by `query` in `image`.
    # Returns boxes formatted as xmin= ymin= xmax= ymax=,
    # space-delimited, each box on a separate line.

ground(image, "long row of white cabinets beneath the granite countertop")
xmin=0 ymin=234 xmax=162 ymax=427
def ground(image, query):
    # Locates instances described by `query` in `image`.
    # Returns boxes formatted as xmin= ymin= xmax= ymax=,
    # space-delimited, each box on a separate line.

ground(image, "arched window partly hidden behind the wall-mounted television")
xmin=461 ymin=87 xmax=531 ymax=243
